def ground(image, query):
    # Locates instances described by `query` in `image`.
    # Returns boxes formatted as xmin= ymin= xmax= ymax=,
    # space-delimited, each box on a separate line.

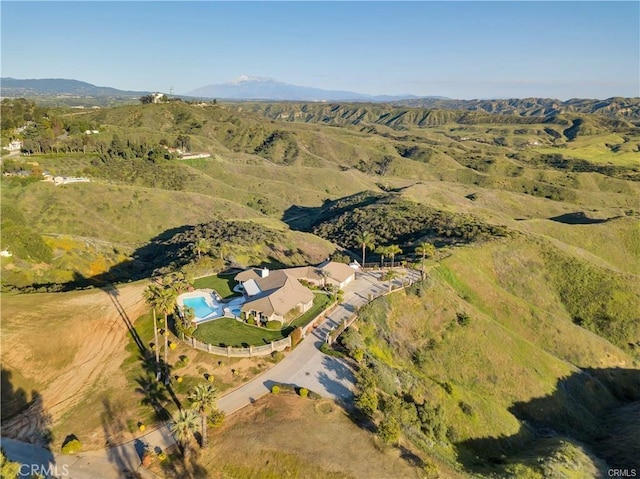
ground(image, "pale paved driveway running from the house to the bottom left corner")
xmin=0 ymin=269 xmax=420 ymax=479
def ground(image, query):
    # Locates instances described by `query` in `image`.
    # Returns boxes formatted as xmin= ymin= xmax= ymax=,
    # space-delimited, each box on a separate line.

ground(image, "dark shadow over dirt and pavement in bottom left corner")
xmin=0 ymin=368 xmax=56 ymax=470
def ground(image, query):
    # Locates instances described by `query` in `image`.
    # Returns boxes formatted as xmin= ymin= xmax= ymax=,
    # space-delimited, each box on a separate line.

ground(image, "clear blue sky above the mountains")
xmin=1 ymin=1 xmax=640 ymax=99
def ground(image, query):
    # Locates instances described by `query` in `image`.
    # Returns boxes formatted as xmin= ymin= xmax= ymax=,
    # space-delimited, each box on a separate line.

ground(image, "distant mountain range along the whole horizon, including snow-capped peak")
xmin=0 ymin=75 xmax=640 ymax=126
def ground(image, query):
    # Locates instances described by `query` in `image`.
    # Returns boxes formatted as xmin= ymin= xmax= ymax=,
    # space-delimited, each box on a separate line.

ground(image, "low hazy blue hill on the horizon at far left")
xmin=0 ymin=77 xmax=149 ymax=98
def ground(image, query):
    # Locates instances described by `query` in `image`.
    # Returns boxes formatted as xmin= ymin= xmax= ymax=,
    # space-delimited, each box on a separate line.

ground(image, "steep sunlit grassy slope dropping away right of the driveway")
xmin=343 ymin=239 xmax=640 ymax=477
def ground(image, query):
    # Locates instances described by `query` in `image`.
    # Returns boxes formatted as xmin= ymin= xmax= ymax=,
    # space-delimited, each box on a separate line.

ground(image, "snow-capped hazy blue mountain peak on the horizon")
xmin=186 ymin=75 xmax=436 ymax=102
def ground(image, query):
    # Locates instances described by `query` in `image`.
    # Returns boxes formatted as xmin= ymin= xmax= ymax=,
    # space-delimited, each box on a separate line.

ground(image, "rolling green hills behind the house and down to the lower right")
xmin=0 ymin=99 xmax=640 ymax=477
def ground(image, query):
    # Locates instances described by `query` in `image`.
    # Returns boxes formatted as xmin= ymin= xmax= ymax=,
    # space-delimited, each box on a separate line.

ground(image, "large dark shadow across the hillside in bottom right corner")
xmin=455 ymin=368 xmax=640 ymax=474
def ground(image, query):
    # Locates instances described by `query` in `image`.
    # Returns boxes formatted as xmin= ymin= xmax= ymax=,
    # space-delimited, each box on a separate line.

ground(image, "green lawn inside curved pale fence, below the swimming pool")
xmin=193 ymin=318 xmax=284 ymax=348
